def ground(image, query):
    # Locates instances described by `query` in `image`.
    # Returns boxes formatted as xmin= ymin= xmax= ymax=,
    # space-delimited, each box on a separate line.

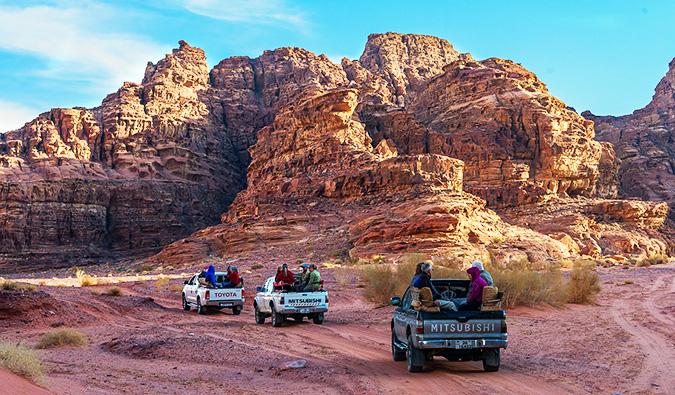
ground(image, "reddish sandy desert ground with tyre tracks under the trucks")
xmin=0 ymin=262 xmax=675 ymax=394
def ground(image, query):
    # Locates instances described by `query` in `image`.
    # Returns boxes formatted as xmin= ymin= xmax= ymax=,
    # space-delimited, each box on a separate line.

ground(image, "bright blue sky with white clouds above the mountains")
xmin=0 ymin=0 xmax=675 ymax=132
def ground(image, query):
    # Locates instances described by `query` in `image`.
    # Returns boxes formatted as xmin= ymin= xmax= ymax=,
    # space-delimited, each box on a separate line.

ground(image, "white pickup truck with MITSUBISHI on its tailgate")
xmin=253 ymin=277 xmax=328 ymax=327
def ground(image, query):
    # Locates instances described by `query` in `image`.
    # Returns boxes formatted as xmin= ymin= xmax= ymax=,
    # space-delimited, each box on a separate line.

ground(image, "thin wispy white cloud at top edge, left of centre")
xmin=184 ymin=0 xmax=307 ymax=28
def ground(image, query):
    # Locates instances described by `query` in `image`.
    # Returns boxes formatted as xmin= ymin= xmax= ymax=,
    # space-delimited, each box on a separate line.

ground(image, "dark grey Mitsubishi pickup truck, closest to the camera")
xmin=391 ymin=279 xmax=507 ymax=372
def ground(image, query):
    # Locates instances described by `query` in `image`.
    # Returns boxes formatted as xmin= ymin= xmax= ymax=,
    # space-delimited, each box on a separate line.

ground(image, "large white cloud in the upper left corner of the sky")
xmin=0 ymin=1 xmax=165 ymax=92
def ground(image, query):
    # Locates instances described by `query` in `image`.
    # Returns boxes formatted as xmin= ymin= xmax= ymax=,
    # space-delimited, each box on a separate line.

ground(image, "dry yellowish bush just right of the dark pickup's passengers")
xmin=490 ymin=267 xmax=565 ymax=308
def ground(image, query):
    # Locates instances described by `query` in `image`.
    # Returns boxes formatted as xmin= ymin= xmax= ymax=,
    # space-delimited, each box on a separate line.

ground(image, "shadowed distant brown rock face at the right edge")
xmin=582 ymin=59 xmax=675 ymax=212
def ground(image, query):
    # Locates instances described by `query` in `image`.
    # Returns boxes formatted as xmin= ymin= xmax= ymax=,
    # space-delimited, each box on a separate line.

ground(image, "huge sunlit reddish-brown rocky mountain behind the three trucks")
xmin=0 ymin=33 xmax=673 ymax=270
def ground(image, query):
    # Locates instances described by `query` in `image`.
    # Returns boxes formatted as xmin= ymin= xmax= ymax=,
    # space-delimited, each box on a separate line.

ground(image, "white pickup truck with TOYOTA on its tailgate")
xmin=182 ymin=272 xmax=245 ymax=315
